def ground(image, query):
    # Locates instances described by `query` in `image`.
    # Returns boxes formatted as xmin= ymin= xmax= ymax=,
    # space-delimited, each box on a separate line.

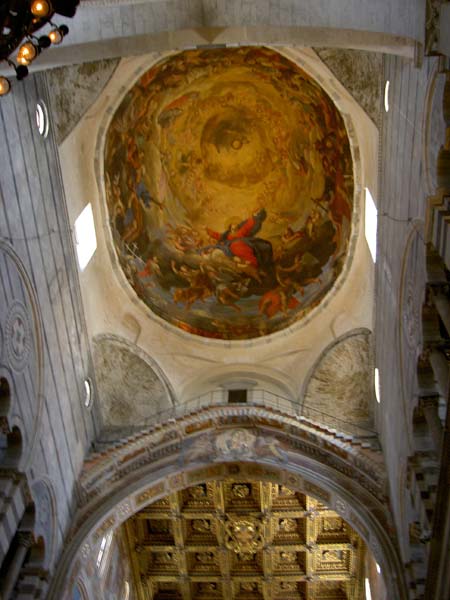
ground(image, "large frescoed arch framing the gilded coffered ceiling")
xmin=49 ymin=407 xmax=407 ymax=600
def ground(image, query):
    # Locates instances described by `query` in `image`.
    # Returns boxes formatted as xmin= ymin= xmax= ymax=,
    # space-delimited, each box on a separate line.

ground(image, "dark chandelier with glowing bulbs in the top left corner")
xmin=0 ymin=0 xmax=79 ymax=96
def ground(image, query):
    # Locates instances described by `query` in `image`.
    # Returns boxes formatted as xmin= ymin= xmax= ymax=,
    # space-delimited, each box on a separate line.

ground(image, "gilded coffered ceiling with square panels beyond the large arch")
xmin=124 ymin=479 xmax=365 ymax=600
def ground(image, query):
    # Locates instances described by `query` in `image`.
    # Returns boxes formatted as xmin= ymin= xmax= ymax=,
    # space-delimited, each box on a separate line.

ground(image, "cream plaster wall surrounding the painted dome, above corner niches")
xmin=59 ymin=49 xmax=378 ymax=412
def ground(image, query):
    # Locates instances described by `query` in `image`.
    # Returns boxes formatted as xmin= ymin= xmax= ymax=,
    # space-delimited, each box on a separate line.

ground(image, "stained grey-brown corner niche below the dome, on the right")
xmin=301 ymin=328 xmax=375 ymax=437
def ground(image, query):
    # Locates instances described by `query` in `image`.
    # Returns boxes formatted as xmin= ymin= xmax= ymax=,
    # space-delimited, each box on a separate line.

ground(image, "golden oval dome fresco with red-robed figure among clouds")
xmin=105 ymin=48 xmax=353 ymax=340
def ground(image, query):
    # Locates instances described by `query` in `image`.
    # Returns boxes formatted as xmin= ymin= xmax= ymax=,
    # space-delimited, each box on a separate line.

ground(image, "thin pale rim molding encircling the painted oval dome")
xmin=93 ymin=43 xmax=370 ymax=348
